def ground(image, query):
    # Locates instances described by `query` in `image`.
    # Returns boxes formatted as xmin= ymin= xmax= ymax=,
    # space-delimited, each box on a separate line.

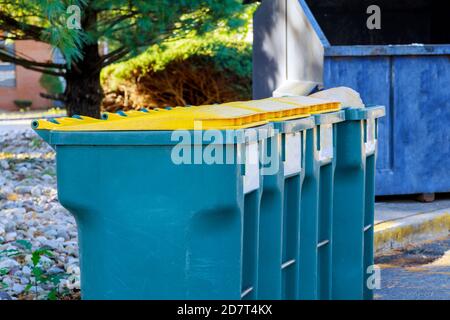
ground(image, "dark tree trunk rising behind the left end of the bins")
xmin=65 ymin=10 xmax=103 ymax=118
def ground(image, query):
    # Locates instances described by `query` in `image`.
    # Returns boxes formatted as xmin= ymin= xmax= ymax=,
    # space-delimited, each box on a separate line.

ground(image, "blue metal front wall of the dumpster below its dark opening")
xmin=324 ymin=45 xmax=450 ymax=195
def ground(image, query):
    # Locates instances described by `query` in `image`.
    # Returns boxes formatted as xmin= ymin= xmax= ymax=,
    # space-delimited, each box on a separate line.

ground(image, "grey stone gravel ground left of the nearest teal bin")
xmin=0 ymin=130 xmax=80 ymax=299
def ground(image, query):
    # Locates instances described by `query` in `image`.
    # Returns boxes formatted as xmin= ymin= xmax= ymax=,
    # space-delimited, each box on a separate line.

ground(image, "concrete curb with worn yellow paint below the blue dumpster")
xmin=374 ymin=208 xmax=450 ymax=254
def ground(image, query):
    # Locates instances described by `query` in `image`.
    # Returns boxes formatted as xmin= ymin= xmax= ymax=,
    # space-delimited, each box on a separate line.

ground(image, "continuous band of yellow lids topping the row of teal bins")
xmin=33 ymin=96 xmax=340 ymax=131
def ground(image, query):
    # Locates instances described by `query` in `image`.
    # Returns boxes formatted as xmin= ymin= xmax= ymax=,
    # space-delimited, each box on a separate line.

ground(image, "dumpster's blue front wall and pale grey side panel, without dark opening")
xmin=253 ymin=0 xmax=450 ymax=195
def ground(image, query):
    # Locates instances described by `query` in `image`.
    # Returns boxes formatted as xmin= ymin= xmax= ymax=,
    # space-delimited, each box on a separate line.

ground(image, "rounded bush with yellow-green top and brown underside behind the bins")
xmin=101 ymin=6 xmax=255 ymax=111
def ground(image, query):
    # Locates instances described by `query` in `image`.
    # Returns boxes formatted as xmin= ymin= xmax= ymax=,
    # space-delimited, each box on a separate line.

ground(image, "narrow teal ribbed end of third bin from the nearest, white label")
xmin=299 ymin=111 xmax=345 ymax=300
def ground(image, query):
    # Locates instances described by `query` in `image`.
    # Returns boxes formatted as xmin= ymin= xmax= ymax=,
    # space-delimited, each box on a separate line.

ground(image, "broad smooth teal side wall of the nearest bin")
xmin=51 ymin=129 xmax=272 ymax=299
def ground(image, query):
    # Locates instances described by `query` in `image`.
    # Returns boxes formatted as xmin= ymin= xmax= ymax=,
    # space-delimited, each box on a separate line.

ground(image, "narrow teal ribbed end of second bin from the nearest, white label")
xmin=258 ymin=117 xmax=314 ymax=299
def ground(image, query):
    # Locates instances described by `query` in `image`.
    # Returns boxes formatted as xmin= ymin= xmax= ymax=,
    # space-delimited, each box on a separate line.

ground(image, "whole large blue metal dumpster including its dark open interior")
xmin=253 ymin=0 xmax=450 ymax=195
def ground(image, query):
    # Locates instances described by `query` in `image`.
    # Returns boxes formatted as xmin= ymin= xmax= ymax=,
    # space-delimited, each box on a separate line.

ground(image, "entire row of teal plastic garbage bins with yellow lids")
xmin=32 ymin=97 xmax=384 ymax=300
